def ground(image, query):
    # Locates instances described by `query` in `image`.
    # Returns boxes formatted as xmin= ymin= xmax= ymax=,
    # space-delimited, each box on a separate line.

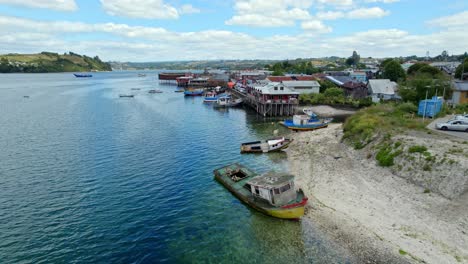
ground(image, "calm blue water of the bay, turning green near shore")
xmin=0 ymin=72 xmax=347 ymax=263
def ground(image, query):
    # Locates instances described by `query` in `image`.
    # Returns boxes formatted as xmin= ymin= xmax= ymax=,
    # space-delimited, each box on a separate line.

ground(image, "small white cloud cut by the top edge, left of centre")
xmin=100 ymin=0 xmax=179 ymax=19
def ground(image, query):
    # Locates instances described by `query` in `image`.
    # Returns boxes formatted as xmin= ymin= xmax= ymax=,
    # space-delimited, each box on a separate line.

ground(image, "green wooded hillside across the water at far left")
xmin=0 ymin=52 xmax=112 ymax=73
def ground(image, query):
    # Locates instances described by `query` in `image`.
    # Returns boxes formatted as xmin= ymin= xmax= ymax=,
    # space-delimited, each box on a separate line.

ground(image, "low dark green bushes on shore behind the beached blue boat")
xmin=299 ymin=87 xmax=372 ymax=107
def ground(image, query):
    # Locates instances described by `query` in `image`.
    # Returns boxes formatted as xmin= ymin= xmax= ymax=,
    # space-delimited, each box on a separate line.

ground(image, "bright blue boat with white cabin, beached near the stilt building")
xmin=282 ymin=108 xmax=333 ymax=131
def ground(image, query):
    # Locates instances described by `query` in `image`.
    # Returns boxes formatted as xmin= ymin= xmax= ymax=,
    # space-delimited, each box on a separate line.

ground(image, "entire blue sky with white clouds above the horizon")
xmin=0 ymin=0 xmax=468 ymax=62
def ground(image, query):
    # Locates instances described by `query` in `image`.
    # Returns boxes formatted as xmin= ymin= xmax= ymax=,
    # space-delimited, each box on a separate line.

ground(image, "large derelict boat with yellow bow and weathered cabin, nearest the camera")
xmin=214 ymin=163 xmax=308 ymax=219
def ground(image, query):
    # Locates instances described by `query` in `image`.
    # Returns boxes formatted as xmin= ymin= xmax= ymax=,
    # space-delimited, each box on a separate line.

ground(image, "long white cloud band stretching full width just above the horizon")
xmin=0 ymin=16 xmax=468 ymax=61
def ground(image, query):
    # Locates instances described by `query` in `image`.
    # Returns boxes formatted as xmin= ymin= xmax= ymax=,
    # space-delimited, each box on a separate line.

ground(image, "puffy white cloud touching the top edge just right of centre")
xmin=225 ymin=0 xmax=312 ymax=27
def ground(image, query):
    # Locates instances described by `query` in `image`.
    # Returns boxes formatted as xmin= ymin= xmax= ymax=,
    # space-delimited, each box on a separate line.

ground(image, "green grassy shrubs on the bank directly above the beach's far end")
xmin=343 ymin=103 xmax=426 ymax=149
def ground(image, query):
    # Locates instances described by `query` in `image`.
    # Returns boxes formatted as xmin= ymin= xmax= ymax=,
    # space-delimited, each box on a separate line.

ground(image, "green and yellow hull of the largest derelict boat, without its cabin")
xmin=214 ymin=163 xmax=308 ymax=219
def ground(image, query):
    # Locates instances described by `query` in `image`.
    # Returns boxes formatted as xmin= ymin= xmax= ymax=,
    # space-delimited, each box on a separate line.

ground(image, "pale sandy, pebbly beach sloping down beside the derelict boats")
xmin=287 ymin=124 xmax=468 ymax=263
